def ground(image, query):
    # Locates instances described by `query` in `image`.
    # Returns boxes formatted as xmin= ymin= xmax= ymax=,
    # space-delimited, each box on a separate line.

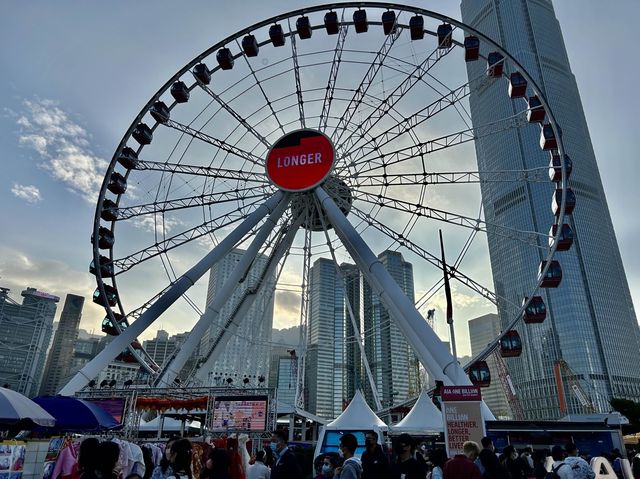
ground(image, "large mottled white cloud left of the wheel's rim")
xmin=14 ymin=99 xmax=109 ymax=203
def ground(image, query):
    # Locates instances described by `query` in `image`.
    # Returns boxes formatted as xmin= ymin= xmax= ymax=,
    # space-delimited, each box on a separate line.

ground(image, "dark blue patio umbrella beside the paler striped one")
xmin=33 ymin=396 xmax=120 ymax=432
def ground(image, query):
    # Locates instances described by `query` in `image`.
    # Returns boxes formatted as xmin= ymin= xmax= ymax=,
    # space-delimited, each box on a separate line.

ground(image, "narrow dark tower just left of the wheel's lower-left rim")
xmin=40 ymin=294 xmax=84 ymax=395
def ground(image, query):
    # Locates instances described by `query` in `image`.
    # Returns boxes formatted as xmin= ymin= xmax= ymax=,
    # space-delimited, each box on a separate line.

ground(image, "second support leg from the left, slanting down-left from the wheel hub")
xmin=156 ymin=194 xmax=290 ymax=387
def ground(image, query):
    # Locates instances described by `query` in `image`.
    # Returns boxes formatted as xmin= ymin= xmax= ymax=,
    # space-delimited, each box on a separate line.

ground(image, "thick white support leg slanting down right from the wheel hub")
xmin=315 ymin=187 xmax=493 ymax=419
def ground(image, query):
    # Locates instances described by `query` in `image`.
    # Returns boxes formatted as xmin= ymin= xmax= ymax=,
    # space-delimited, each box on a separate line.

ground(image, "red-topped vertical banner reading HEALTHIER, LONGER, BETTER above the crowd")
xmin=441 ymin=386 xmax=485 ymax=457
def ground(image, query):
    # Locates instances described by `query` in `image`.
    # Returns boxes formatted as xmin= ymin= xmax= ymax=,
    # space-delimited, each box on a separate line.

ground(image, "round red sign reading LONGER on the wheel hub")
xmin=266 ymin=130 xmax=335 ymax=191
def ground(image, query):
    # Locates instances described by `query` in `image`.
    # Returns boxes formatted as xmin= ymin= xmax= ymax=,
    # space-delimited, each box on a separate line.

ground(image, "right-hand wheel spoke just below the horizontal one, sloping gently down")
xmin=354 ymin=191 xmax=549 ymax=250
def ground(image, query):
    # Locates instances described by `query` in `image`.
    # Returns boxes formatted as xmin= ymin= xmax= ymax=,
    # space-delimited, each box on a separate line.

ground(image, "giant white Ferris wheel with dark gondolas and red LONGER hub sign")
xmin=62 ymin=2 xmax=575 ymax=408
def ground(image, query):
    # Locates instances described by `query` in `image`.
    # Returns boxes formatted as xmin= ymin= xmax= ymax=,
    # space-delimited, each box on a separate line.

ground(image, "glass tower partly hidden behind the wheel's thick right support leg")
xmin=363 ymin=250 xmax=420 ymax=406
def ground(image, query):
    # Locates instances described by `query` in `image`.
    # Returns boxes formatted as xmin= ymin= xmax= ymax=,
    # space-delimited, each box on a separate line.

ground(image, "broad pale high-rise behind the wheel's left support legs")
xmin=200 ymin=249 xmax=275 ymax=384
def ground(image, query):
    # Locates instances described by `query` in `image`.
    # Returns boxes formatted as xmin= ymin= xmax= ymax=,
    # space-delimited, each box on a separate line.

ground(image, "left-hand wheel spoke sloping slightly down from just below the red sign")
xmin=113 ymin=186 xmax=270 ymax=220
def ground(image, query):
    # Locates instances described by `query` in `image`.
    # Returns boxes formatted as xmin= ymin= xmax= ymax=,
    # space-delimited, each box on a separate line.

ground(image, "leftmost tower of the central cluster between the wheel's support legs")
xmin=305 ymin=258 xmax=347 ymax=419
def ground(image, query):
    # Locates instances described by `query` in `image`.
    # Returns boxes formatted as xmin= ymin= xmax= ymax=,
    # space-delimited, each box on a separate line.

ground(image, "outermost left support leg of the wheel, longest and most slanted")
xmin=59 ymin=191 xmax=288 ymax=396
